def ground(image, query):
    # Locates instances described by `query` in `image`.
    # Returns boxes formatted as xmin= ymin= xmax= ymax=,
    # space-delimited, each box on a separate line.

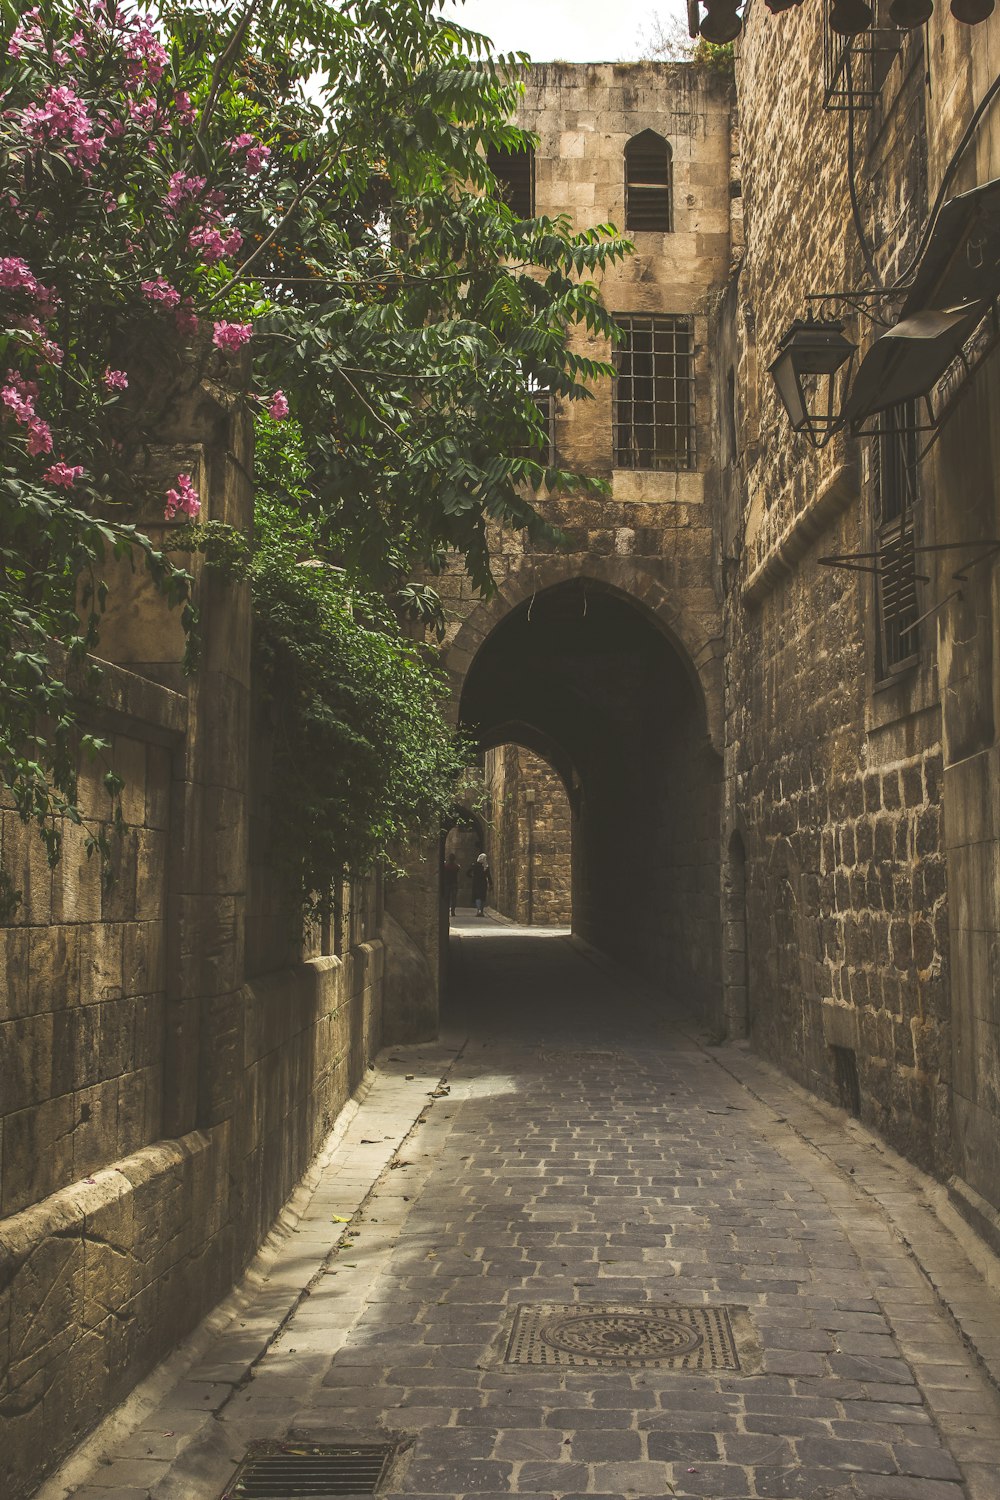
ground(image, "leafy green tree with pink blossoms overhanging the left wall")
xmin=0 ymin=0 xmax=625 ymax=906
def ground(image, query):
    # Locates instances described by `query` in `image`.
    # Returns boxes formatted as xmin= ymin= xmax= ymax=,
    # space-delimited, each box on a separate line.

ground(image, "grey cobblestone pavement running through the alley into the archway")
xmin=52 ymin=920 xmax=1000 ymax=1500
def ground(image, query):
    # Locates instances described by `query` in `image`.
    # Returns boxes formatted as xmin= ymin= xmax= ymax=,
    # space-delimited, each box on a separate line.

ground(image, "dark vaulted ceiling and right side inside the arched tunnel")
xmin=462 ymin=579 xmax=721 ymax=1013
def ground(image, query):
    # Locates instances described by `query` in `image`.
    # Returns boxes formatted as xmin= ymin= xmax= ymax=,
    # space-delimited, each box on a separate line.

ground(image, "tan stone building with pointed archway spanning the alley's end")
xmin=390 ymin=63 xmax=732 ymax=1029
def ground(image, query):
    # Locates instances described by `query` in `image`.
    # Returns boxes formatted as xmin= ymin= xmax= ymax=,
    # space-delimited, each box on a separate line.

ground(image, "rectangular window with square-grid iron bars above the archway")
xmin=615 ymin=315 xmax=694 ymax=470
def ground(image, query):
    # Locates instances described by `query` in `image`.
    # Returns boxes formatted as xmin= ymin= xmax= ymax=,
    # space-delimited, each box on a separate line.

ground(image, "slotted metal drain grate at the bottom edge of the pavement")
xmin=222 ymin=1443 xmax=396 ymax=1500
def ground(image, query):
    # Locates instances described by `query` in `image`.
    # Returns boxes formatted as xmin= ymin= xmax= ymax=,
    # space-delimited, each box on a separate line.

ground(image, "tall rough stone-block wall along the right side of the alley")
xmin=728 ymin=6 xmax=1000 ymax=1205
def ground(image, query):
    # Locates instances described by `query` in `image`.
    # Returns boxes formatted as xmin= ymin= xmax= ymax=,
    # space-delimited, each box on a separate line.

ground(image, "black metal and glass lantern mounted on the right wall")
xmin=769 ymin=318 xmax=856 ymax=449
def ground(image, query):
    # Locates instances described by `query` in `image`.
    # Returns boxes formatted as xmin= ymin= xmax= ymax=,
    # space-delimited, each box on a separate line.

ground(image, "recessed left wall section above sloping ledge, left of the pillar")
xmin=0 ymin=690 xmax=173 ymax=1215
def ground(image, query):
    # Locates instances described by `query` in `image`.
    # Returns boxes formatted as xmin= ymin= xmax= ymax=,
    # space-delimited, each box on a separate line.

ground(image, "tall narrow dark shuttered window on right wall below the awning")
xmin=871 ymin=402 xmax=919 ymax=675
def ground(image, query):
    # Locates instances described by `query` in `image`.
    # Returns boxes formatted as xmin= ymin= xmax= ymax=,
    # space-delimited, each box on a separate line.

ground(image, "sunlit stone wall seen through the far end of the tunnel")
xmin=486 ymin=746 xmax=573 ymax=927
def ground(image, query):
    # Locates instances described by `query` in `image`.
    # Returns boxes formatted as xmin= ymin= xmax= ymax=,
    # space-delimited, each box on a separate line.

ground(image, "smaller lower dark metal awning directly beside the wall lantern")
xmin=844 ymin=302 xmax=987 ymax=432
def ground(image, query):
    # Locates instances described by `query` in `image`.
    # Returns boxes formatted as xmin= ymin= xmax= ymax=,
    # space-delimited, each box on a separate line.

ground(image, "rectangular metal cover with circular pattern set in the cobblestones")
xmin=505 ymin=1304 xmax=757 ymax=1370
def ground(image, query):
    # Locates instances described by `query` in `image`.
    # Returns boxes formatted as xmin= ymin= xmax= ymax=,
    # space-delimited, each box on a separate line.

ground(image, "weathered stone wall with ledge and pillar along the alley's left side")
xmin=0 ymin=375 xmax=384 ymax=1500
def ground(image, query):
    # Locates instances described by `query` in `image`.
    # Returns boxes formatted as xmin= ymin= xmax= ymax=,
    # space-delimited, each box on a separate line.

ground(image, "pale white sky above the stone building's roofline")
xmin=443 ymin=0 xmax=687 ymax=63
